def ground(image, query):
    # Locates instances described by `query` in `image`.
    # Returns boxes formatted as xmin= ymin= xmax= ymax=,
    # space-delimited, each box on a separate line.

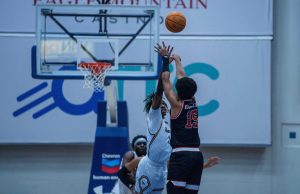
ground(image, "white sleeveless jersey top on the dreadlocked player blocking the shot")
xmin=146 ymin=108 xmax=172 ymax=164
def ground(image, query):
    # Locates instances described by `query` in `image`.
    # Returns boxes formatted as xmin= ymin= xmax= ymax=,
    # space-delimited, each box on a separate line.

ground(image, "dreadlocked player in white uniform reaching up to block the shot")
xmin=135 ymin=41 xmax=173 ymax=194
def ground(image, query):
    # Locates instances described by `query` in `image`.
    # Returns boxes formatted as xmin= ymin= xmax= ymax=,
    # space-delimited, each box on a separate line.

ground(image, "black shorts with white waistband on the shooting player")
xmin=168 ymin=151 xmax=203 ymax=191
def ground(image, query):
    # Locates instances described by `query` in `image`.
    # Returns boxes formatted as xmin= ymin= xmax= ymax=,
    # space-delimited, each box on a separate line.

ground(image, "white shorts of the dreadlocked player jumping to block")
xmin=135 ymin=156 xmax=166 ymax=194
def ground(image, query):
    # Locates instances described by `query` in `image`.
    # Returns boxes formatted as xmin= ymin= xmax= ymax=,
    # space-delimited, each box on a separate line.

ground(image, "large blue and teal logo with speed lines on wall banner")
xmin=13 ymin=63 xmax=220 ymax=119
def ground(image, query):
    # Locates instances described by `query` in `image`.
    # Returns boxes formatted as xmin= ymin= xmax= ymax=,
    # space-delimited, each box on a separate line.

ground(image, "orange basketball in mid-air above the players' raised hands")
xmin=165 ymin=11 xmax=186 ymax=33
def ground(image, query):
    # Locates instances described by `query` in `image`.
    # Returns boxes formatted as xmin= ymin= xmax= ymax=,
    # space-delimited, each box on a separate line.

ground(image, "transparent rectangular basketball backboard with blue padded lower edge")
xmin=32 ymin=5 xmax=160 ymax=80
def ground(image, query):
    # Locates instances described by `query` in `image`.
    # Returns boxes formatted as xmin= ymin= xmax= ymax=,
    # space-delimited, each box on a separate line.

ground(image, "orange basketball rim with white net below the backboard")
xmin=77 ymin=62 xmax=111 ymax=92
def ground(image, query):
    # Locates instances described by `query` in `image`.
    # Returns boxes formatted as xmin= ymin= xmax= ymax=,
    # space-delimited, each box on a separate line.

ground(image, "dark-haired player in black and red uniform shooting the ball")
xmin=156 ymin=43 xmax=203 ymax=194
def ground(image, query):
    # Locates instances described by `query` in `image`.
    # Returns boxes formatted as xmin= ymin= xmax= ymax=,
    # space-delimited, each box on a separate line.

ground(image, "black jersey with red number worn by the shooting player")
xmin=170 ymin=99 xmax=200 ymax=148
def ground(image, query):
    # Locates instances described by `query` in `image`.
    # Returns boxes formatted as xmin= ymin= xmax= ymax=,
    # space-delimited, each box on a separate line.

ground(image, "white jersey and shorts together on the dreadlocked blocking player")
xmin=135 ymin=108 xmax=171 ymax=194
